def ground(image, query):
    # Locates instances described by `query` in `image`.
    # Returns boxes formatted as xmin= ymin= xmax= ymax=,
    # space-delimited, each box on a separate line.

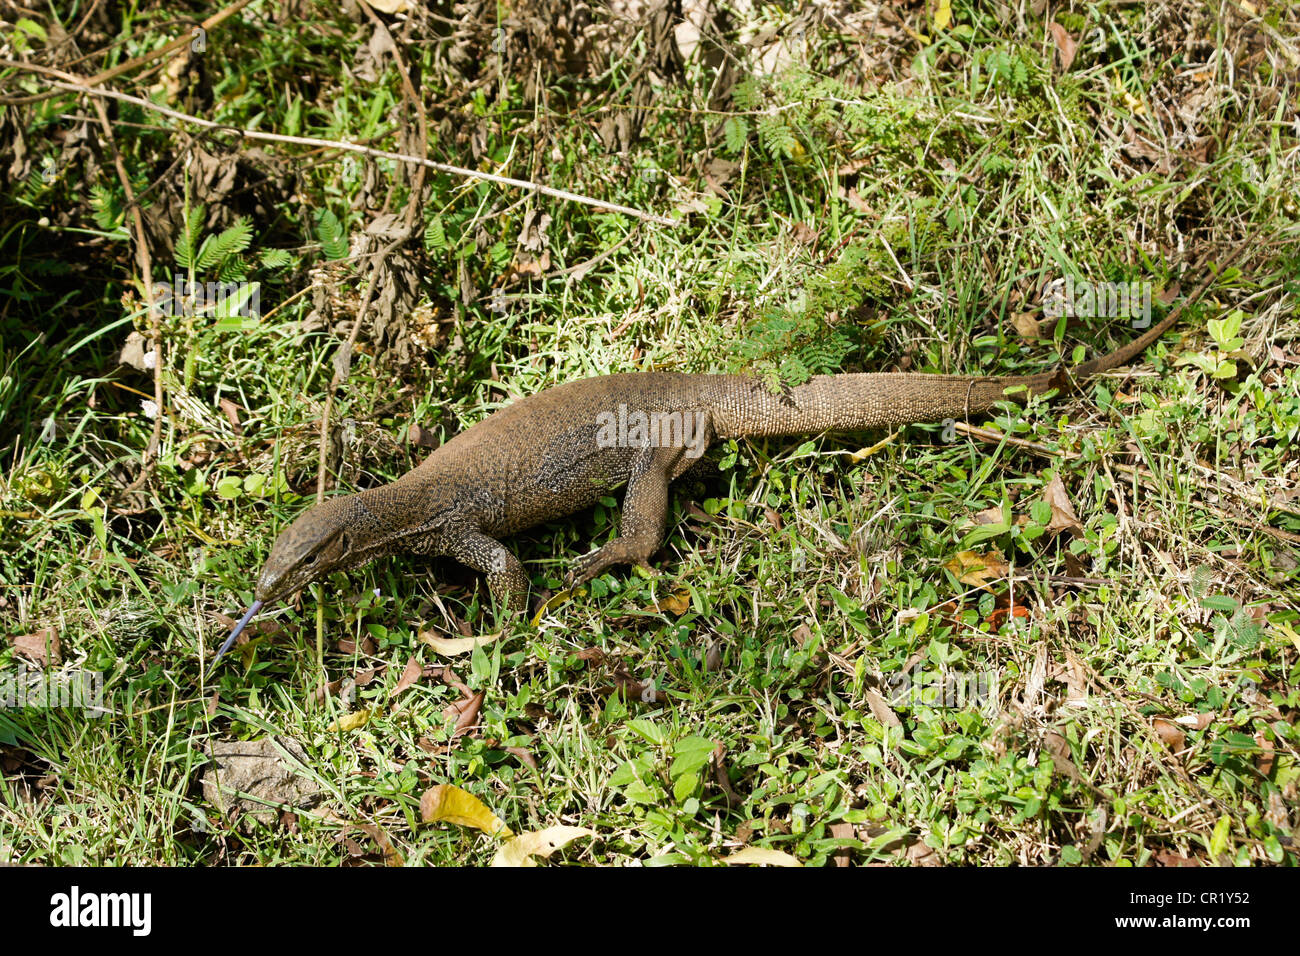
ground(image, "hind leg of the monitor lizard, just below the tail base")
xmin=568 ymin=412 xmax=712 ymax=587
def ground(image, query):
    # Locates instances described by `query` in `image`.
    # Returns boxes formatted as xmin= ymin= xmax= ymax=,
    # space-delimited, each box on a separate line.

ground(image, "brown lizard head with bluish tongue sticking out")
xmin=212 ymin=494 xmax=368 ymax=663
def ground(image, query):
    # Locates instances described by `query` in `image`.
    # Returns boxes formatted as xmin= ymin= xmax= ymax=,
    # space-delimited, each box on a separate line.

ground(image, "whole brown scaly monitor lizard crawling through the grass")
xmin=217 ymin=251 xmax=1245 ymax=657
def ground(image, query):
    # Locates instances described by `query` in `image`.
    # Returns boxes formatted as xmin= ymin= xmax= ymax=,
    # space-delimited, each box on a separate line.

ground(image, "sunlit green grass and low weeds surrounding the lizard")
xmin=0 ymin=3 xmax=1300 ymax=865
